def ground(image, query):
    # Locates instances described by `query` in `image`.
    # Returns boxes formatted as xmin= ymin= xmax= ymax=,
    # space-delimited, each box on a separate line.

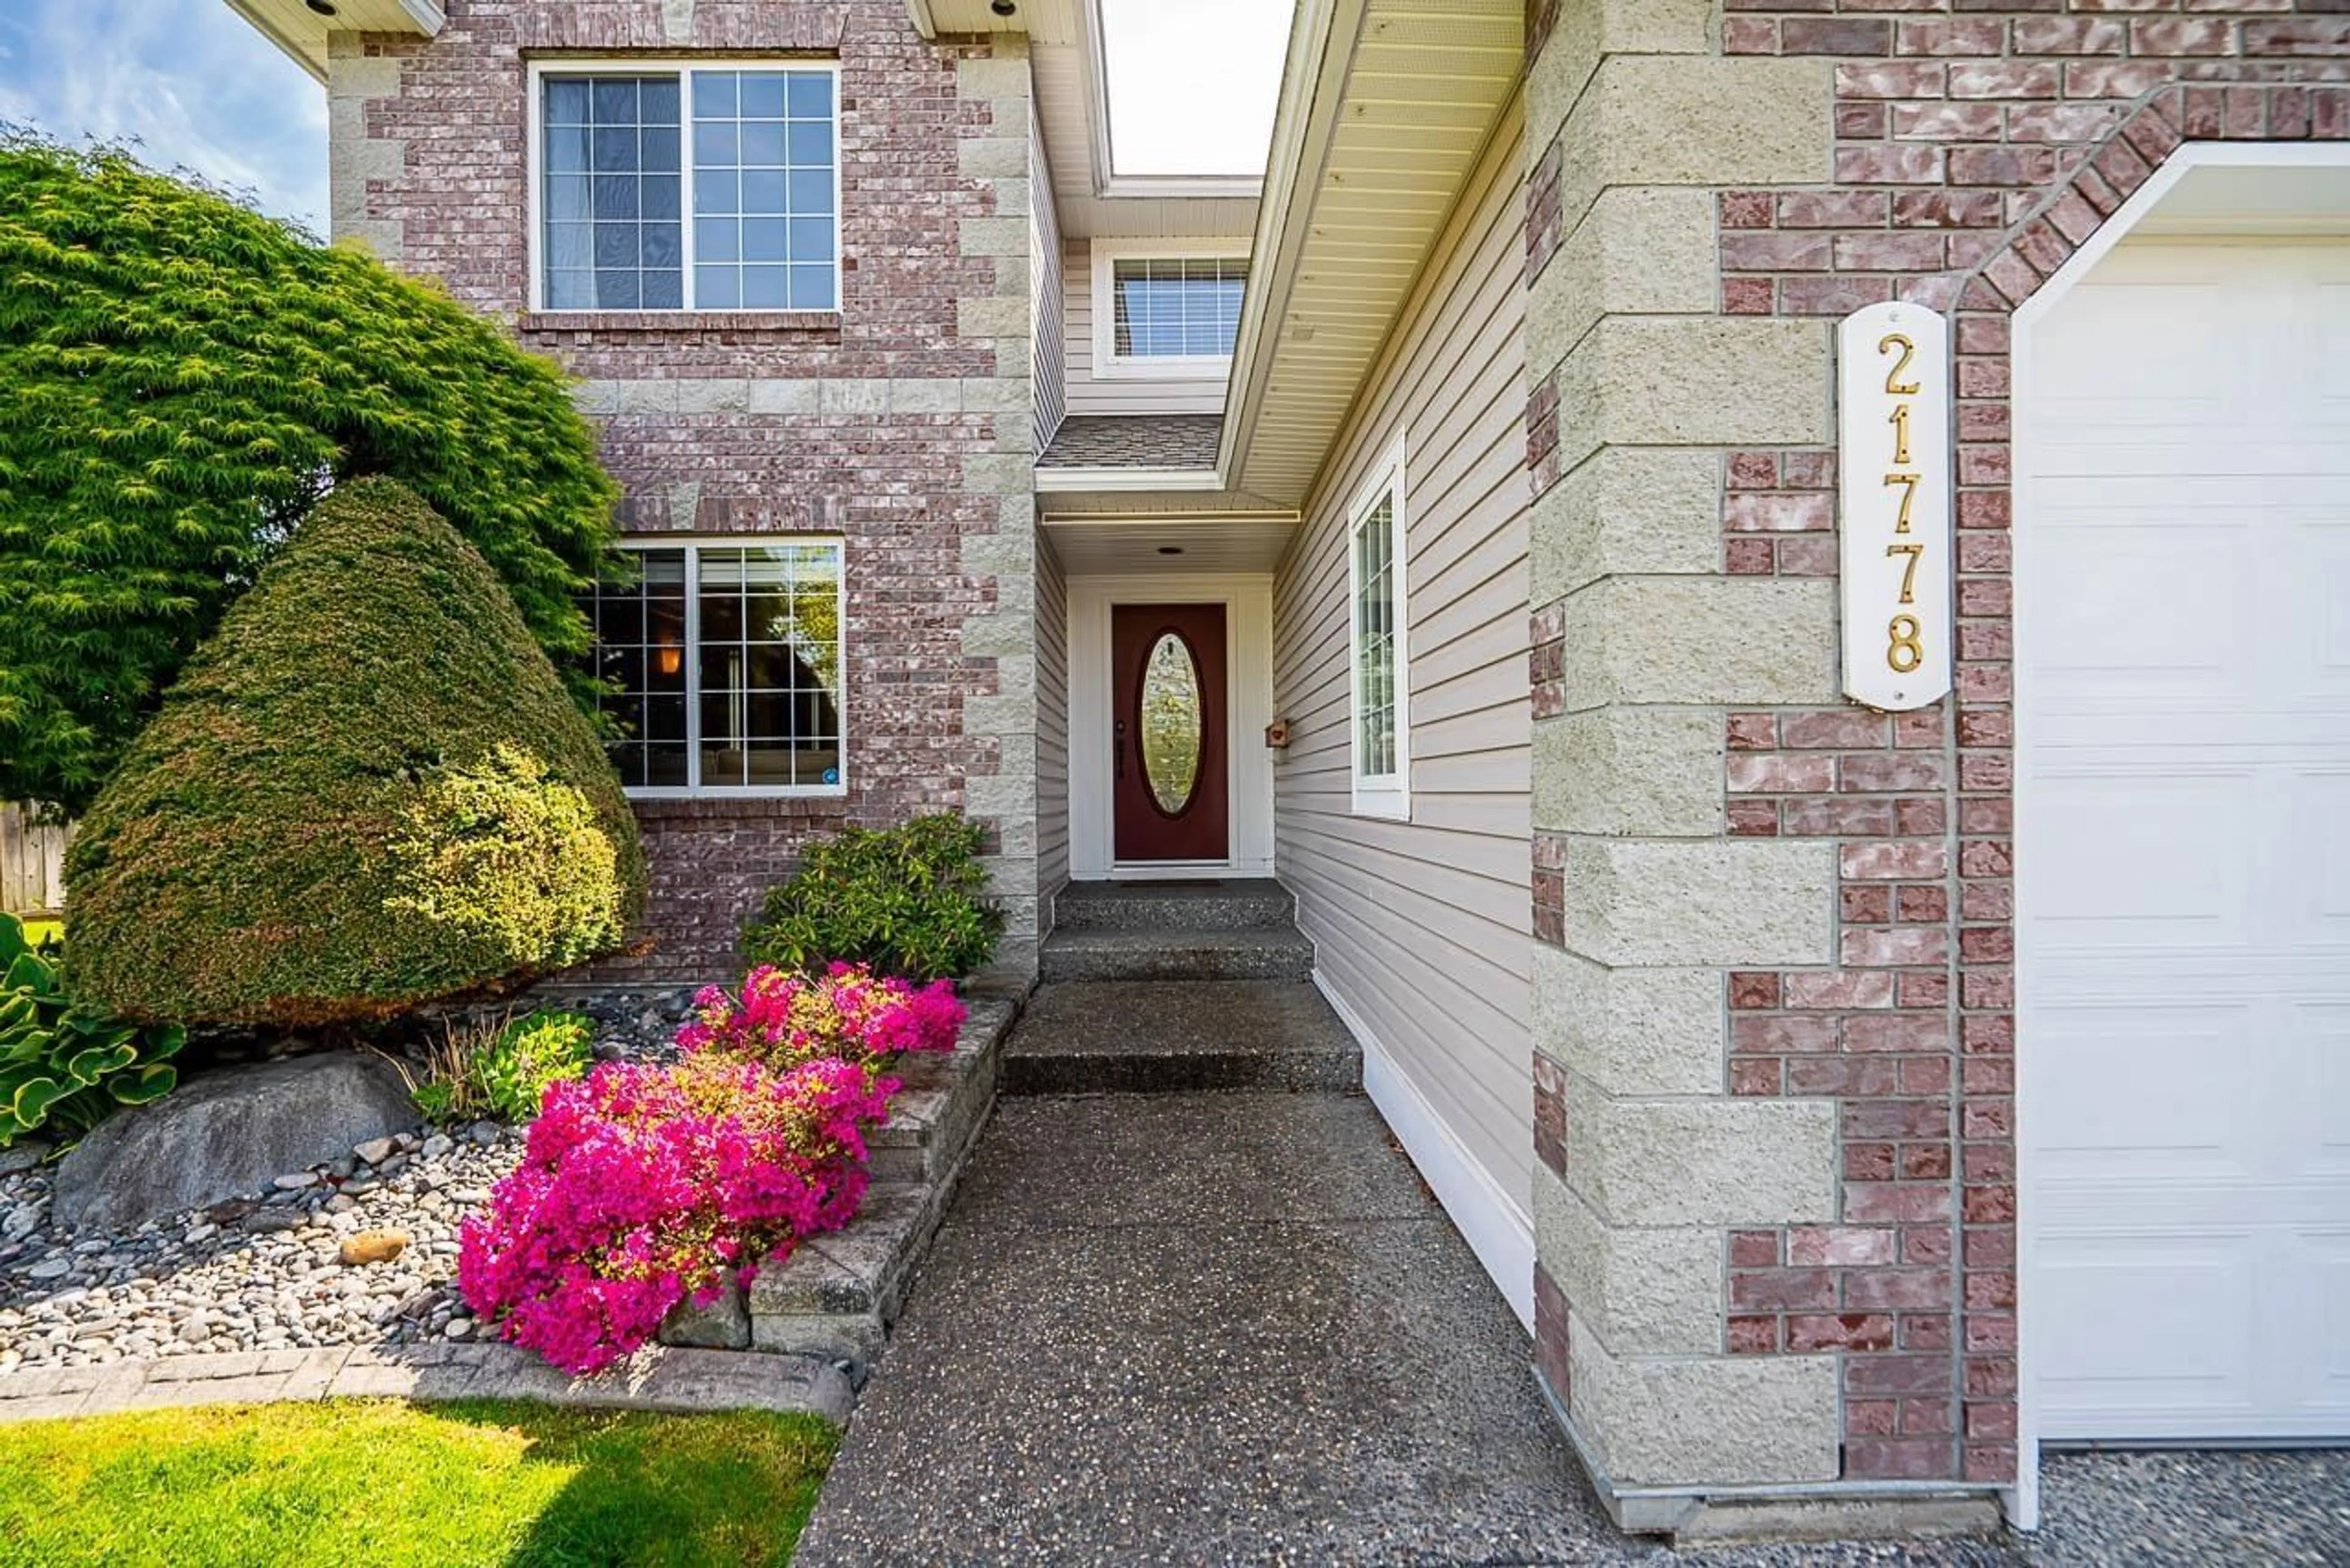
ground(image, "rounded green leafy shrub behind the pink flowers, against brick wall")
xmin=742 ymin=816 xmax=1004 ymax=980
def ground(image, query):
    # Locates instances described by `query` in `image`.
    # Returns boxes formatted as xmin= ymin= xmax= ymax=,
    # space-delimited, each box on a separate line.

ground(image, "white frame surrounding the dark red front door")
xmin=1069 ymin=573 xmax=1274 ymax=881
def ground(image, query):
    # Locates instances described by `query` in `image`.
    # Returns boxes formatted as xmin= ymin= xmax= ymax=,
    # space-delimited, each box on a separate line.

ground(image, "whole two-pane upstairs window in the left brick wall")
xmin=538 ymin=64 xmax=841 ymax=310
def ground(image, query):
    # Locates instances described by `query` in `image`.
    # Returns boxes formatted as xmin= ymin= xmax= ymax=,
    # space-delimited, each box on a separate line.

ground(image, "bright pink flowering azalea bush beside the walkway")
xmin=458 ymin=966 xmax=966 ymax=1375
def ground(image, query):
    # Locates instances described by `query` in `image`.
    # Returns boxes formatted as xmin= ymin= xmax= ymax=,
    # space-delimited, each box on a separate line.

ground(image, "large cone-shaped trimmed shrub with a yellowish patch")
xmin=66 ymin=480 xmax=644 ymax=1025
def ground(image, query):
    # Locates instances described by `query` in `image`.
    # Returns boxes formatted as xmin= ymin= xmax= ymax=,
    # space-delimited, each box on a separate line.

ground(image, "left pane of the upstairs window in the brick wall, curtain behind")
xmin=540 ymin=75 xmax=686 ymax=310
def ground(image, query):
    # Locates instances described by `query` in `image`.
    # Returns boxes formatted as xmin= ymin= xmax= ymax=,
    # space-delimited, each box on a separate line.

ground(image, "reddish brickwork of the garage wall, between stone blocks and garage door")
xmin=1528 ymin=0 xmax=2350 ymax=1484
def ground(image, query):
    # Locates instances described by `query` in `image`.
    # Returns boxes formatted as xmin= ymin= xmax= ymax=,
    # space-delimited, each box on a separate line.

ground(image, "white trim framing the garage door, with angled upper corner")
xmin=2005 ymin=141 xmax=2350 ymax=1531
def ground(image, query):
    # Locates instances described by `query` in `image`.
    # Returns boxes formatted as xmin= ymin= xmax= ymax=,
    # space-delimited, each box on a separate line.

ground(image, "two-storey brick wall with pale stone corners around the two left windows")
xmin=329 ymin=0 xmax=1036 ymax=983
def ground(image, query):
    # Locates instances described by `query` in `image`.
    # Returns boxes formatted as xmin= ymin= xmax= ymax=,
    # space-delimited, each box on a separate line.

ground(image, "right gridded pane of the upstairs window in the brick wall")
xmin=693 ymin=70 xmax=839 ymax=310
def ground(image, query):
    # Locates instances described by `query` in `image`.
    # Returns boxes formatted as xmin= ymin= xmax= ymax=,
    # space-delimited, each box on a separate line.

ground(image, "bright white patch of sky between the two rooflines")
xmin=1102 ymin=0 xmax=1295 ymax=174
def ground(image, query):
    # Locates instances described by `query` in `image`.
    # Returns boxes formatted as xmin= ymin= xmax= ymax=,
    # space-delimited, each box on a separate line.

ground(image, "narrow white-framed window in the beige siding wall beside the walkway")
xmin=1346 ymin=451 xmax=1412 ymax=818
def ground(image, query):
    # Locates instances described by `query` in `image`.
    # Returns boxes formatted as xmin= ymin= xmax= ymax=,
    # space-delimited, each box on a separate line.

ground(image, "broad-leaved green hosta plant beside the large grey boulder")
xmin=0 ymin=914 xmax=185 ymax=1149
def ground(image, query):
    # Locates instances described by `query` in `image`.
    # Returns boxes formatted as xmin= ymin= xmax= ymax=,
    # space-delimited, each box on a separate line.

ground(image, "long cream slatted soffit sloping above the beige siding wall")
xmin=1225 ymin=0 xmax=1525 ymax=506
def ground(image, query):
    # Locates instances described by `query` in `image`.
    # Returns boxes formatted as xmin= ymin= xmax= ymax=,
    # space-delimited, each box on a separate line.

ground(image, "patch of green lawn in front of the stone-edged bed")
xmin=0 ymin=1398 xmax=837 ymax=1568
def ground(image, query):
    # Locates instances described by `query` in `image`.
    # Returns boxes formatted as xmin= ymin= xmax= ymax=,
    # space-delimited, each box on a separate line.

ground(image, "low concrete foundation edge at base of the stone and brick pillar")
xmin=1535 ymin=1368 xmax=2007 ymax=1547
